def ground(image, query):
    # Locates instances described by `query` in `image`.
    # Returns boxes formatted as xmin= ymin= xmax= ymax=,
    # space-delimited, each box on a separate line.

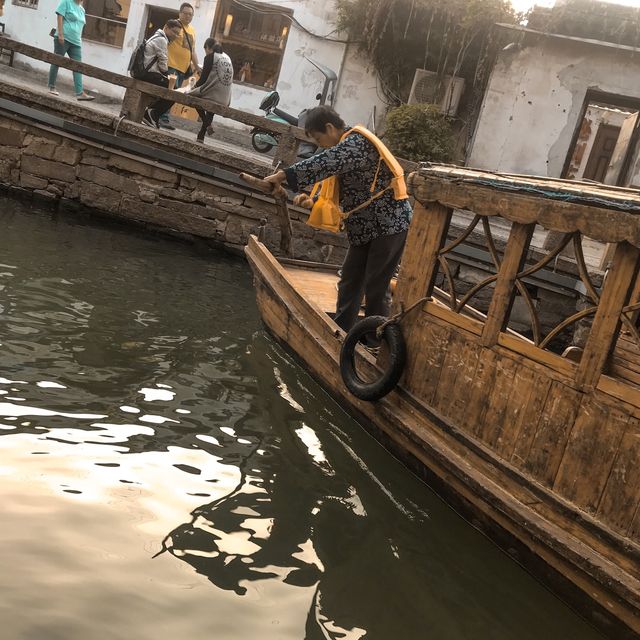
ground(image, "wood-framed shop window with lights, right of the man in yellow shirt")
xmin=212 ymin=0 xmax=293 ymax=89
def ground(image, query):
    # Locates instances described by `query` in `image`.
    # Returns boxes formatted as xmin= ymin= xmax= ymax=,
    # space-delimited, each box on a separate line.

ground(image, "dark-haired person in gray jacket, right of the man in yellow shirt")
xmin=189 ymin=38 xmax=233 ymax=142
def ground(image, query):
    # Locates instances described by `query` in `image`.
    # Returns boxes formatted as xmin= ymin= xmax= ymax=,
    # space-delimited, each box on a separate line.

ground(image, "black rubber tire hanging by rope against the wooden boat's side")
xmin=340 ymin=316 xmax=407 ymax=402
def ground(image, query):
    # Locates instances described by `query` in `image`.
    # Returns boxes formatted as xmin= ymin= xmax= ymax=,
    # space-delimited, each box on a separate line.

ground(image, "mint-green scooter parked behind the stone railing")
xmin=251 ymin=56 xmax=337 ymax=158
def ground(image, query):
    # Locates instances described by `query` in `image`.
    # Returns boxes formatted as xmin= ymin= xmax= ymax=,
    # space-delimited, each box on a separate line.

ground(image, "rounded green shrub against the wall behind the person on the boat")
xmin=384 ymin=104 xmax=453 ymax=162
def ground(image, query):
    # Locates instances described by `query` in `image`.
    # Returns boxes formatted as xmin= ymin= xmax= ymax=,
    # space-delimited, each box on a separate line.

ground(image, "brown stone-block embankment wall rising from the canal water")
xmin=0 ymin=116 xmax=346 ymax=263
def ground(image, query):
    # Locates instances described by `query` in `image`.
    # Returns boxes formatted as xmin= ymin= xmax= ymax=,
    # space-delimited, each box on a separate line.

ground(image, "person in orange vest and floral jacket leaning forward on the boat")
xmin=265 ymin=106 xmax=412 ymax=331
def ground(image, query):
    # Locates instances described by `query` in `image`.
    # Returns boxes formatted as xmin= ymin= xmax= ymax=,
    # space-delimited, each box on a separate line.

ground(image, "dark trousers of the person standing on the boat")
xmin=334 ymin=231 xmax=407 ymax=331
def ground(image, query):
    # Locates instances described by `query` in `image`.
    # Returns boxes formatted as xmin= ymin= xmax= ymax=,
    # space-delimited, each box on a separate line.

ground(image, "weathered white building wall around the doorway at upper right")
xmin=467 ymin=38 xmax=640 ymax=177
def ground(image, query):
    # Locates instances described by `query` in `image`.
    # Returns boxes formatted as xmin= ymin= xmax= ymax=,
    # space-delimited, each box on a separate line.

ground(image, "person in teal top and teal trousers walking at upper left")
xmin=49 ymin=0 xmax=93 ymax=100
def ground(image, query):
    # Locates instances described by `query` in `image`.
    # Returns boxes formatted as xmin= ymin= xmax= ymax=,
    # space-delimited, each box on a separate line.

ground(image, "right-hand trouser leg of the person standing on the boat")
xmin=364 ymin=231 xmax=407 ymax=316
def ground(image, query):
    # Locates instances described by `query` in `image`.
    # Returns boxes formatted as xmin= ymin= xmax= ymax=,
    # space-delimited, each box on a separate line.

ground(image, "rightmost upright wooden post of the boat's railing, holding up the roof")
xmin=576 ymin=242 xmax=640 ymax=391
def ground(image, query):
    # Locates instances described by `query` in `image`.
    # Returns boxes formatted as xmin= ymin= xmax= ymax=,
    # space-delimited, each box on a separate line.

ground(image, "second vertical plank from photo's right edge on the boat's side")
xmin=553 ymin=397 xmax=629 ymax=513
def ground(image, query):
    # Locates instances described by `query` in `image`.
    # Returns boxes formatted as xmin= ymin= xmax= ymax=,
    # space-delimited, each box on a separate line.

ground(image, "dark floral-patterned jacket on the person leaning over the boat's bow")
xmin=285 ymin=133 xmax=412 ymax=246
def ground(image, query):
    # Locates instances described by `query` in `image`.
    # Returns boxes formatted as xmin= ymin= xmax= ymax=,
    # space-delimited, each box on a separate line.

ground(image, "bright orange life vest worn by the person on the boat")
xmin=307 ymin=125 xmax=409 ymax=233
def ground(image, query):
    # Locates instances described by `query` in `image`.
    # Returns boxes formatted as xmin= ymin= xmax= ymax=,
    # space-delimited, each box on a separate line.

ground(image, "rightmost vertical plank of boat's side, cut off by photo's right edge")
xmin=597 ymin=418 xmax=640 ymax=535
